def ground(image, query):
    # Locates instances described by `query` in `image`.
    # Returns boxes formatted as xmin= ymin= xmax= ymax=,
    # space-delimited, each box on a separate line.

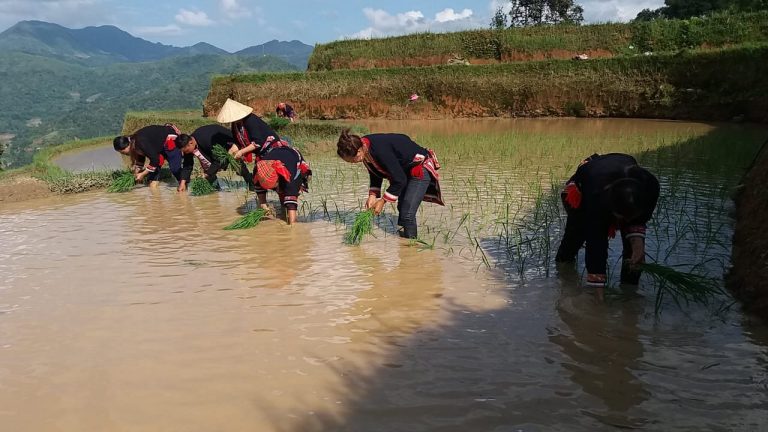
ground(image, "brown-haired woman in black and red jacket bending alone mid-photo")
xmin=336 ymin=129 xmax=443 ymax=239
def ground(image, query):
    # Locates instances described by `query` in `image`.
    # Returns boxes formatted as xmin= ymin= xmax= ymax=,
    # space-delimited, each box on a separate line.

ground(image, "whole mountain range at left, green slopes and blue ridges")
xmin=0 ymin=21 xmax=313 ymax=167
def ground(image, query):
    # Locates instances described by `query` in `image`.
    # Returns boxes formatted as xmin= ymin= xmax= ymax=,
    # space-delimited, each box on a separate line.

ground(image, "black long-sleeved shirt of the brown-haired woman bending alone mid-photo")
xmin=363 ymin=134 xmax=429 ymax=202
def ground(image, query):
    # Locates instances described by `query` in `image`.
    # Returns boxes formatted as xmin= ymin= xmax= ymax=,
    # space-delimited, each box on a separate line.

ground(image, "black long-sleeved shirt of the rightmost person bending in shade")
xmin=569 ymin=153 xmax=660 ymax=274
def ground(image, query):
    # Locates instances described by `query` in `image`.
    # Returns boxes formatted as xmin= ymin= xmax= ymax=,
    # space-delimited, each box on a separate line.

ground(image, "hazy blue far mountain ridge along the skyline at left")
xmin=0 ymin=21 xmax=312 ymax=68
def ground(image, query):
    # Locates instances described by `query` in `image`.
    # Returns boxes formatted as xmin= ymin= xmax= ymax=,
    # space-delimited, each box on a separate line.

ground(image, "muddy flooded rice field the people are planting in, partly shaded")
xmin=0 ymin=120 xmax=768 ymax=432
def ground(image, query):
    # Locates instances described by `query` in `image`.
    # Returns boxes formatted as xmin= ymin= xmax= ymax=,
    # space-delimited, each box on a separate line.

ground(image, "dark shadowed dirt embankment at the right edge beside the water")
xmin=728 ymin=143 xmax=768 ymax=319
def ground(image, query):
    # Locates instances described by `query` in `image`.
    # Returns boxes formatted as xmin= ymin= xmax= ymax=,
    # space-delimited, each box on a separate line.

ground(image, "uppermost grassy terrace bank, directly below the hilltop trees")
xmin=309 ymin=12 xmax=768 ymax=71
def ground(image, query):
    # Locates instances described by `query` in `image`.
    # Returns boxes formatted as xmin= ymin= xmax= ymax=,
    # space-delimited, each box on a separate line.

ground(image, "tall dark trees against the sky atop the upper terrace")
xmin=491 ymin=0 xmax=584 ymax=28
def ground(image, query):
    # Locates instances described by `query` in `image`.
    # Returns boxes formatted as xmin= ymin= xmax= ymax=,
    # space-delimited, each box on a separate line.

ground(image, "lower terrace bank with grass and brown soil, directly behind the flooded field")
xmin=205 ymin=45 xmax=768 ymax=121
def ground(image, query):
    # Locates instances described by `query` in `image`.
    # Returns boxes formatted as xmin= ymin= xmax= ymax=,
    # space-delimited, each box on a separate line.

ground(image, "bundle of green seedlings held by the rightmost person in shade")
xmin=638 ymin=263 xmax=723 ymax=314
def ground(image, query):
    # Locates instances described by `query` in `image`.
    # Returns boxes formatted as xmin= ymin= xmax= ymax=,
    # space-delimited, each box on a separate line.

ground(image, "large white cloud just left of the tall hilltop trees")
xmin=347 ymin=8 xmax=476 ymax=39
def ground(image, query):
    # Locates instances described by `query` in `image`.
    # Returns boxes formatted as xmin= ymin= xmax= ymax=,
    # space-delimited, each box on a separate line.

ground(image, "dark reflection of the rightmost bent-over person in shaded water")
xmin=549 ymin=294 xmax=648 ymax=414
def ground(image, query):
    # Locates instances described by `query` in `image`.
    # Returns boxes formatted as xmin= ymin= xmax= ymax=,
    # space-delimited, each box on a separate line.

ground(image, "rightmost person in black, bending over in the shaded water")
xmin=555 ymin=153 xmax=659 ymax=288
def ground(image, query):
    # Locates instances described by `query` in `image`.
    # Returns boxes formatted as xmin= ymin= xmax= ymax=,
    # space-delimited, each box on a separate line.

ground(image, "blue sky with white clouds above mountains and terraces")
xmin=0 ymin=0 xmax=663 ymax=51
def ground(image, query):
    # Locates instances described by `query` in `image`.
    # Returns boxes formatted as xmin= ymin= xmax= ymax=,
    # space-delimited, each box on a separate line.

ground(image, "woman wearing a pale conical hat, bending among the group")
xmin=216 ymin=99 xmax=278 ymax=188
